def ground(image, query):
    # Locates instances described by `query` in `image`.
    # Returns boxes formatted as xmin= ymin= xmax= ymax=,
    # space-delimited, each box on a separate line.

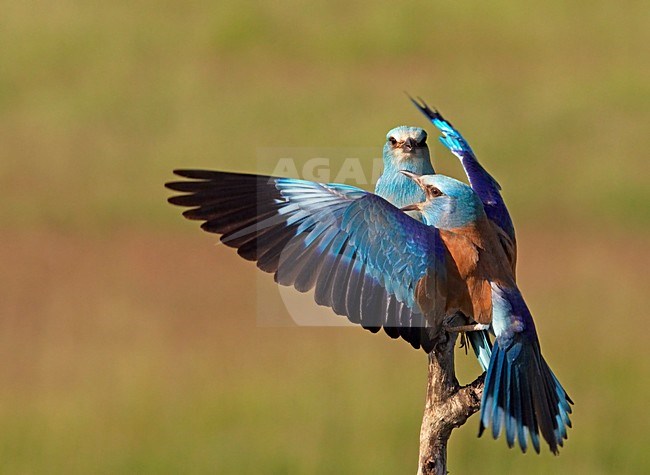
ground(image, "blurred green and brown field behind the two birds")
xmin=0 ymin=0 xmax=650 ymax=474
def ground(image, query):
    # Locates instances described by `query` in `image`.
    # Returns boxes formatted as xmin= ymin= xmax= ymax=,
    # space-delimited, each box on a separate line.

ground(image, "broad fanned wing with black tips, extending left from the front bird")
xmin=166 ymin=170 xmax=446 ymax=352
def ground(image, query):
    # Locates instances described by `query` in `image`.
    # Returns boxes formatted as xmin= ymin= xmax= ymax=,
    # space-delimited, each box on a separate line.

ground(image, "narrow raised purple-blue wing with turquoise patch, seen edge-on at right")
xmin=411 ymin=98 xmax=515 ymax=246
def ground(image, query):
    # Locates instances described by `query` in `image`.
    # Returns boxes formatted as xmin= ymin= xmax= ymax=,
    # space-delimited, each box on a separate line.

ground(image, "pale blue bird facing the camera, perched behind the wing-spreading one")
xmin=375 ymin=126 xmax=492 ymax=371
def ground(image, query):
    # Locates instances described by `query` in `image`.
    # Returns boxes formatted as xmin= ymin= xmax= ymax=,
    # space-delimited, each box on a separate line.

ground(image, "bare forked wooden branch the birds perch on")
xmin=418 ymin=333 xmax=485 ymax=475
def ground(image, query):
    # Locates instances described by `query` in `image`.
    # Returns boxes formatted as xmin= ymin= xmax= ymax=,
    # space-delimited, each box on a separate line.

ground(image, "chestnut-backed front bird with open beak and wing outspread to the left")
xmin=167 ymin=170 xmax=571 ymax=453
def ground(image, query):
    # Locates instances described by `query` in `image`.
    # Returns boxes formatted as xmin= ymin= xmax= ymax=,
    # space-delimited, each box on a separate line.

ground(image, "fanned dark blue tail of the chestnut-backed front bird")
xmin=479 ymin=335 xmax=573 ymax=454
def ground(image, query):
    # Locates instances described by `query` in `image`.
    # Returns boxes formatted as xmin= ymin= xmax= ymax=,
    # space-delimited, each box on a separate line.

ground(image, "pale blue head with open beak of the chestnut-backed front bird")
xmin=401 ymin=170 xmax=485 ymax=229
